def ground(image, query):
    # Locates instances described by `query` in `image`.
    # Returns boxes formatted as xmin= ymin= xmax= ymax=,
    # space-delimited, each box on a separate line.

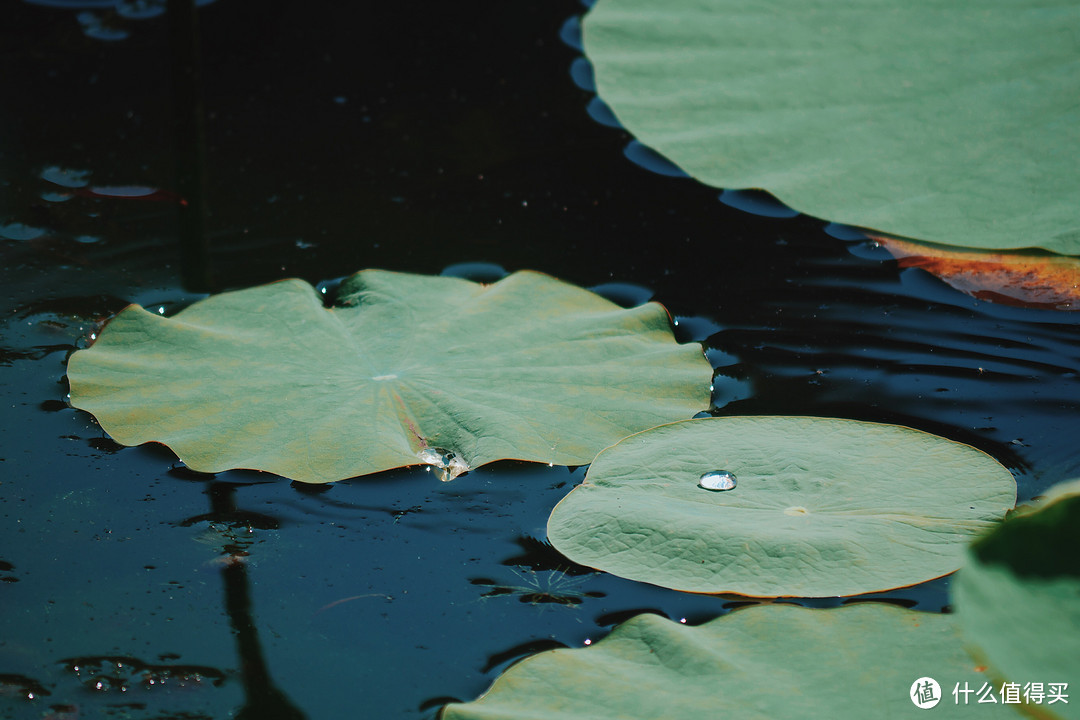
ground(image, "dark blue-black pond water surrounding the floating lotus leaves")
xmin=0 ymin=0 xmax=1080 ymax=719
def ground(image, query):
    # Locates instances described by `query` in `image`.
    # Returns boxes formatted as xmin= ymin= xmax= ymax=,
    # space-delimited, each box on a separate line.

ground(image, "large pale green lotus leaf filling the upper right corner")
xmin=583 ymin=0 xmax=1080 ymax=255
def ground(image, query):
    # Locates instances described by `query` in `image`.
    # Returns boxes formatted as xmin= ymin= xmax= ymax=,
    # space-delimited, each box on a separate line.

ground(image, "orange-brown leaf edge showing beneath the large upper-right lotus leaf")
xmin=873 ymin=236 xmax=1080 ymax=310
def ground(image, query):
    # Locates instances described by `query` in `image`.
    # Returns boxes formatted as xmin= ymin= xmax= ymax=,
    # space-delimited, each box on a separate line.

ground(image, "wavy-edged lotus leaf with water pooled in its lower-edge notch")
xmin=68 ymin=271 xmax=712 ymax=483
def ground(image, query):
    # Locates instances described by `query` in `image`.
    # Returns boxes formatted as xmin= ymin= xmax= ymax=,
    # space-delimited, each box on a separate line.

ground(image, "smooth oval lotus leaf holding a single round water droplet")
xmin=548 ymin=417 xmax=1016 ymax=597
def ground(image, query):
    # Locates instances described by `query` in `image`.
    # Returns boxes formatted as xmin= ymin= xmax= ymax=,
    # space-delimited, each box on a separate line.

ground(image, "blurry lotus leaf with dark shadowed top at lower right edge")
xmin=953 ymin=481 xmax=1080 ymax=718
